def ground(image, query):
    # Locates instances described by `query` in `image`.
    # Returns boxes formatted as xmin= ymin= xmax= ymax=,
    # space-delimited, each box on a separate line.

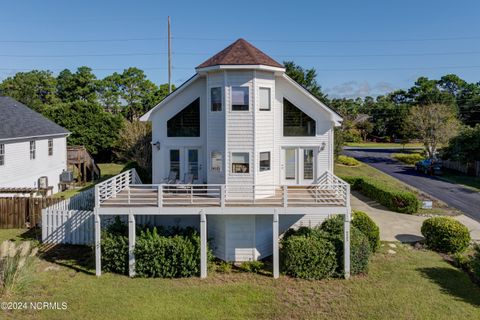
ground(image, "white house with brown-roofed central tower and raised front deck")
xmin=95 ymin=39 xmax=350 ymax=276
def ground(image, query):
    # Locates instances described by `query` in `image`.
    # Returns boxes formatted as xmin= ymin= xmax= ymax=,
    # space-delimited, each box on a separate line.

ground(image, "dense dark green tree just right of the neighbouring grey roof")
xmin=46 ymin=100 xmax=124 ymax=156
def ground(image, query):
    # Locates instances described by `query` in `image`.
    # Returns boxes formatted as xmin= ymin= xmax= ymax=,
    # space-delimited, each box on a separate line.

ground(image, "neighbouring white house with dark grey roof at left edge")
xmin=0 ymin=97 xmax=69 ymax=193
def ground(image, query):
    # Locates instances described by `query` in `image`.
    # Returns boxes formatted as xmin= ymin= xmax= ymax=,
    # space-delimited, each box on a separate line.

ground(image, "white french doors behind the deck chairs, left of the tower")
xmin=169 ymin=147 xmax=203 ymax=183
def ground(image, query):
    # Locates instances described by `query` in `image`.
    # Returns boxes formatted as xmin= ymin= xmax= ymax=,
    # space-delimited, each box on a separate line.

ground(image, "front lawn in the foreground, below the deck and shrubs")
xmin=0 ymin=230 xmax=480 ymax=320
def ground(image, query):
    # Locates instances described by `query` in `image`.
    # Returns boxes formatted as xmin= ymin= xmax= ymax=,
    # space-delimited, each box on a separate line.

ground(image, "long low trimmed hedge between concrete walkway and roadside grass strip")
xmin=344 ymin=177 xmax=420 ymax=214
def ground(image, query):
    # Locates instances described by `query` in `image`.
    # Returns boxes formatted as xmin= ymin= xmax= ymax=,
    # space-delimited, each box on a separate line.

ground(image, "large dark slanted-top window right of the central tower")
xmin=283 ymin=99 xmax=315 ymax=137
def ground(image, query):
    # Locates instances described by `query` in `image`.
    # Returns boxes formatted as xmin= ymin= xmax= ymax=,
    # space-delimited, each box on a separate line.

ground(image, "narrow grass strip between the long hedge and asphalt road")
xmin=335 ymin=162 xmax=458 ymax=215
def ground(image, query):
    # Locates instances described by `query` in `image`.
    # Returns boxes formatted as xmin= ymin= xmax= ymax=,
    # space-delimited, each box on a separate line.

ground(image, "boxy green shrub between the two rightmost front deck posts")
xmin=282 ymin=235 xmax=337 ymax=279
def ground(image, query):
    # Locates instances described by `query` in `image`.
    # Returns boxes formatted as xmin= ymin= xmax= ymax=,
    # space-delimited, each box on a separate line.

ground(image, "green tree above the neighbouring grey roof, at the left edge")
xmin=0 ymin=70 xmax=58 ymax=112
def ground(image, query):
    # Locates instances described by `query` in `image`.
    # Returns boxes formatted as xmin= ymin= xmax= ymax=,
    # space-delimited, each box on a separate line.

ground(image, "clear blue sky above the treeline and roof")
xmin=0 ymin=0 xmax=480 ymax=98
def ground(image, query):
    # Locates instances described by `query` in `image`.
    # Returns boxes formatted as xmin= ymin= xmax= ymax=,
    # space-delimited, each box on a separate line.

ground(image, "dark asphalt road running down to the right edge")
xmin=344 ymin=147 xmax=480 ymax=222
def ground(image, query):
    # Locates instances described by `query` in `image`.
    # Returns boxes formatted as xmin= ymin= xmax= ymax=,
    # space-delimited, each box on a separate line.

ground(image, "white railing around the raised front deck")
xmin=95 ymin=169 xmax=350 ymax=207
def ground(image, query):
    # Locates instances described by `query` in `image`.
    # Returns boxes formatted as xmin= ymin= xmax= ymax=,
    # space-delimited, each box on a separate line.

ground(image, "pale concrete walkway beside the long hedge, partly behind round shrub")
xmin=351 ymin=192 xmax=480 ymax=242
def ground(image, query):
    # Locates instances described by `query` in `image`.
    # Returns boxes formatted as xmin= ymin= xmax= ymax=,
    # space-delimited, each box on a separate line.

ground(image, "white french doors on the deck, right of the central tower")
xmin=280 ymin=147 xmax=317 ymax=185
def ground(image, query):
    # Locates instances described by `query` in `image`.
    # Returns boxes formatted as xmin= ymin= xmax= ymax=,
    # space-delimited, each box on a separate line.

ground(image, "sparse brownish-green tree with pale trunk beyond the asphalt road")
xmin=407 ymin=104 xmax=460 ymax=158
